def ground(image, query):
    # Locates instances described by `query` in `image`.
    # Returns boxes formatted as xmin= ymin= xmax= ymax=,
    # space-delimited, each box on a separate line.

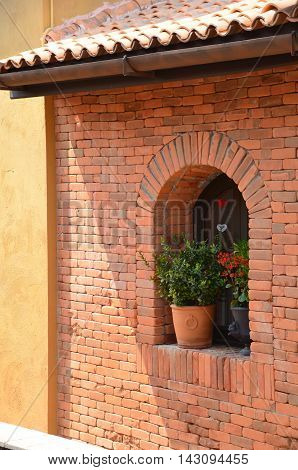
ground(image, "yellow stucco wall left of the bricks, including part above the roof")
xmin=0 ymin=0 xmax=101 ymax=433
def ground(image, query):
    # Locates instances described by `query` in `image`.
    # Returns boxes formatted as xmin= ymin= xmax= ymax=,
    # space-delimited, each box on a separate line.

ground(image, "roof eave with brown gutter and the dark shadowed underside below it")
xmin=0 ymin=25 xmax=298 ymax=97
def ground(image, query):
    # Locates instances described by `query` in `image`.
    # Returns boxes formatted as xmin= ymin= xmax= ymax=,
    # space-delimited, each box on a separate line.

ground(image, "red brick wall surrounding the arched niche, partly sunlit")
xmin=55 ymin=66 xmax=298 ymax=449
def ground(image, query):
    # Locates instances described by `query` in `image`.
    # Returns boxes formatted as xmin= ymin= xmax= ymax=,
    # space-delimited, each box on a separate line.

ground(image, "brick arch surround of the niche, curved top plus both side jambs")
xmin=136 ymin=131 xmax=273 ymax=361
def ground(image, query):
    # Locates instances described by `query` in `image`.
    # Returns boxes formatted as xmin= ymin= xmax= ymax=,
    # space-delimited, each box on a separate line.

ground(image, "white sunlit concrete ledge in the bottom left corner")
xmin=0 ymin=422 xmax=100 ymax=452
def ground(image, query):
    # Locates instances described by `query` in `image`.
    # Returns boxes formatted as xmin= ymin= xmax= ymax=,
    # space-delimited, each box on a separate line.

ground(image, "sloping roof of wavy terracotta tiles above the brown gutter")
xmin=1 ymin=0 xmax=298 ymax=72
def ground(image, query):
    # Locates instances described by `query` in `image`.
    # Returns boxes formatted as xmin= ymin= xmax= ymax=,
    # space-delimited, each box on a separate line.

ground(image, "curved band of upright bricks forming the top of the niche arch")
xmin=138 ymin=131 xmax=271 ymax=214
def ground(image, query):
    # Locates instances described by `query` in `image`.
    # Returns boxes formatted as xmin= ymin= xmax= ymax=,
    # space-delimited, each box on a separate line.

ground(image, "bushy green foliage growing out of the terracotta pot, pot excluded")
xmin=146 ymin=238 xmax=221 ymax=306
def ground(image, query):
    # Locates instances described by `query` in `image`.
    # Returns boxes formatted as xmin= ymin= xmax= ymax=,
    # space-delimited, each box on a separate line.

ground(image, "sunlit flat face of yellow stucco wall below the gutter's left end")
xmin=0 ymin=93 xmax=48 ymax=430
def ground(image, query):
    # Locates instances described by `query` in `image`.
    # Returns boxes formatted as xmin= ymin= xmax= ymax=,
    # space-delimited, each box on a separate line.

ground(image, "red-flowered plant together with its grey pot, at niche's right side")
xmin=218 ymin=240 xmax=250 ymax=356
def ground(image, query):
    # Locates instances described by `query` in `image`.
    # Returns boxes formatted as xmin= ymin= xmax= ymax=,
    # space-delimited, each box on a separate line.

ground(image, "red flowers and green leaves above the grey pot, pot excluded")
xmin=217 ymin=240 xmax=249 ymax=307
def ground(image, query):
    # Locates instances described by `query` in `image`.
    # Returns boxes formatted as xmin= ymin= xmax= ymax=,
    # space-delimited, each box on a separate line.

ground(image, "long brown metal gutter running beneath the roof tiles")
xmin=0 ymin=31 xmax=298 ymax=90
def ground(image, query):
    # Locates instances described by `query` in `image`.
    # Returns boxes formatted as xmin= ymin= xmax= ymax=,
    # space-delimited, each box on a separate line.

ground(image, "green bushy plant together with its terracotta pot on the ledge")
xmin=154 ymin=239 xmax=221 ymax=349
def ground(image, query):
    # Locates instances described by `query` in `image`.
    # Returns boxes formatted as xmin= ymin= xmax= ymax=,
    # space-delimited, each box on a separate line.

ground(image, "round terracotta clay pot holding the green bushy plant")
xmin=171 ymin=305 xmax=215 ymax=349
